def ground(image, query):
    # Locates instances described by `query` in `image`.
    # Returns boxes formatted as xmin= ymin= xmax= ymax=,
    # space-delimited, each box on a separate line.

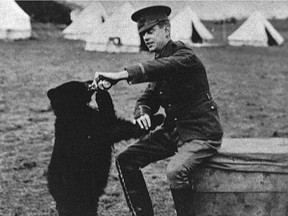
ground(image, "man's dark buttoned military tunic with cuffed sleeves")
xmin=126 ymin=40 xmax=223 ymax=142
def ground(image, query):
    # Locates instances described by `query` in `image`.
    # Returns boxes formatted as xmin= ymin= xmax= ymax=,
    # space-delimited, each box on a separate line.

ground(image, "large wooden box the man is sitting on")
xmin=191 ymin=138 xmax=288 ymax=216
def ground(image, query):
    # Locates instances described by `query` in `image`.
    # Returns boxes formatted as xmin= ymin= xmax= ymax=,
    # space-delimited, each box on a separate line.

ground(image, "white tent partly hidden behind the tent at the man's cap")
xmin=63 ymin=2 xmax=108 ymax=40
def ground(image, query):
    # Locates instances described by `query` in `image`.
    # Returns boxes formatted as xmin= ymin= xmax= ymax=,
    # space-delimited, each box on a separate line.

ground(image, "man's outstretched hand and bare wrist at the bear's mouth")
xmin=92 ymin=71 xmax=129 ymax=90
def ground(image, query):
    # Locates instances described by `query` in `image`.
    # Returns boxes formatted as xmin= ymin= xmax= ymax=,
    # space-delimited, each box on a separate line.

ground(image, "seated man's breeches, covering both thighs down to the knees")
xmin=117 ymin=128 xmax=221 ymax=189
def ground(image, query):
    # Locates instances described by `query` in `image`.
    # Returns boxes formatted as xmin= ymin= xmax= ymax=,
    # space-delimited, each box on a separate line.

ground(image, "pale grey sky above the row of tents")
xmin=64 ymin=0 xmax=288 ymax=20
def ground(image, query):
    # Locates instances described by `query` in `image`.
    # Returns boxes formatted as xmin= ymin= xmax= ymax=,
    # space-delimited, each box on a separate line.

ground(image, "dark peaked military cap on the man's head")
xmin=131 ymin=5 xmax=171 ymax=34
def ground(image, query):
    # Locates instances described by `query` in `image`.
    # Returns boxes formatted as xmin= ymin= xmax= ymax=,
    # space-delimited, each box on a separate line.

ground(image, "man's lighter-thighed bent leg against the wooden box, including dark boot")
xmin=167 ymin=140 xmax=221 ymax=216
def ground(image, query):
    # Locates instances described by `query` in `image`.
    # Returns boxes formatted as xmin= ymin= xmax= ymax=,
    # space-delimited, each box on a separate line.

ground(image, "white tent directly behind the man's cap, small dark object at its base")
xmin=85 ymin=2 xmax=141 ymax=52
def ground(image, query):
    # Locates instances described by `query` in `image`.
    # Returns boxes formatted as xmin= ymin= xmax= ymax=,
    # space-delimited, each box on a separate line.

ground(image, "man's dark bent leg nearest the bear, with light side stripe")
xmin=116 ymin=129 xmax=178 ymax=216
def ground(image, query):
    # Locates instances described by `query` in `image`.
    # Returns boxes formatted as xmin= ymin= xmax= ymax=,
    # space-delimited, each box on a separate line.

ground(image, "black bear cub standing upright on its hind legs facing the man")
xmin=47 ymin=81 xmax=163 ymax=216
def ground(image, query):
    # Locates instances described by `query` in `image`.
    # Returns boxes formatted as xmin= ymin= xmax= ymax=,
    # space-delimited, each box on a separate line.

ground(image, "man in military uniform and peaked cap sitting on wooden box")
xmin=94 ymin=6 xmax=223 ymax=216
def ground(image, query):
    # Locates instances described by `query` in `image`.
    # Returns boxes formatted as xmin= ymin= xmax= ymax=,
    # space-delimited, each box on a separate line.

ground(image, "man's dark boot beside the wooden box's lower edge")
xmin=170 ymin=187 xmax=196 ymax=216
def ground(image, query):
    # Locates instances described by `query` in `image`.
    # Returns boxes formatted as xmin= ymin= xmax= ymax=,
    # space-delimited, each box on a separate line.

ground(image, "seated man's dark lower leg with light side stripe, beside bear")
xmin=116 ymin=162 xmax=154 ymax=216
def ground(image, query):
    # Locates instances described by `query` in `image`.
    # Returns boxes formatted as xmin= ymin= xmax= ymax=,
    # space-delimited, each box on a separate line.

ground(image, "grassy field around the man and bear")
xmin=0 ymin=20 xmax=288 ymax=216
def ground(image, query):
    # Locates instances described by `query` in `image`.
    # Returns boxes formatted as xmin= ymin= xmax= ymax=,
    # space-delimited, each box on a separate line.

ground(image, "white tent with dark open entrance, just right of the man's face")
xmin=171 ymin=6 xmax=214 ymax=44
